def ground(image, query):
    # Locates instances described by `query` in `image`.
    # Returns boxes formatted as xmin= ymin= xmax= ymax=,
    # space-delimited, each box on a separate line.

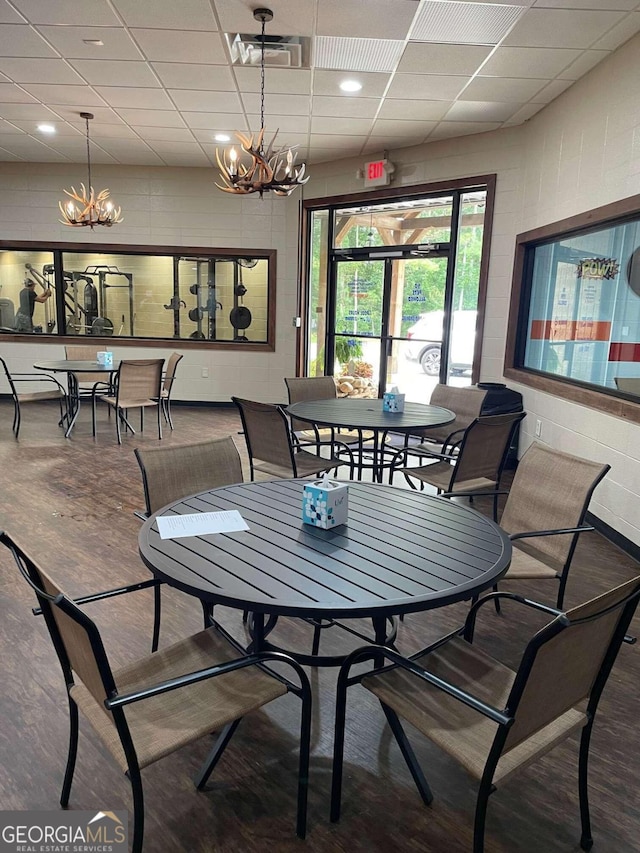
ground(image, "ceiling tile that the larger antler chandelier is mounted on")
xmin=215 ymin=0 xmax=316 ymax=36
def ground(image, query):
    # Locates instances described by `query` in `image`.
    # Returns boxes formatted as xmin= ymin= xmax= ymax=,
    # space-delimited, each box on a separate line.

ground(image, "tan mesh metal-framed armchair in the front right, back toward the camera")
xmin=331 ymin=577 xmax=640 ymax=853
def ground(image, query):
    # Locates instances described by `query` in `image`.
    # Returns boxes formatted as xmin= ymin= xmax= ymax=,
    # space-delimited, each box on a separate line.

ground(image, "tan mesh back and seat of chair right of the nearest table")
xmin=500 ymin=441 xmax=611 ymax=570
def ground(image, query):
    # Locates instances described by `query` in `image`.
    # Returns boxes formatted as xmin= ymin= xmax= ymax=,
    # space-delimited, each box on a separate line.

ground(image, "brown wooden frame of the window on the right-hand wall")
xmin=504 ymin=190 xmax=640 ymax=423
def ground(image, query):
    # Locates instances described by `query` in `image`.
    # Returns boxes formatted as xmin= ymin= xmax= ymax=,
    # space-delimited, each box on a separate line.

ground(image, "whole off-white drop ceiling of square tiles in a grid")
xmin=0 ymin=0 xmax=640 ymax=166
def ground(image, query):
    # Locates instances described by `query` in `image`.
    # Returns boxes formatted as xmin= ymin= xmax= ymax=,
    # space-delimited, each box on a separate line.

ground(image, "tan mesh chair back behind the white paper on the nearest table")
xmin=134 ymin=436 xmax=242 ymax=515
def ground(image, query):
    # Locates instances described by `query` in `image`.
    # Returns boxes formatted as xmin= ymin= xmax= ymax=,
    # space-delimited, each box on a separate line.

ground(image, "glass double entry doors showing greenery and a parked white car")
xmin=330 ymin=253 xmax=450 ymax=402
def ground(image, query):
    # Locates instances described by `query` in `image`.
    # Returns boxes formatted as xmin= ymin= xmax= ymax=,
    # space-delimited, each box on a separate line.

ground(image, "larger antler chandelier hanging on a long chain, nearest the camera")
xmin=216 ymin=9 xmax=309 ymax=197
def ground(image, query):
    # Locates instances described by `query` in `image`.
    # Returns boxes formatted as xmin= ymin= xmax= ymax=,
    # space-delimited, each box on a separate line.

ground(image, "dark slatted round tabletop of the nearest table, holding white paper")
xmin=139 ymin=480 xmax=511 ymax=619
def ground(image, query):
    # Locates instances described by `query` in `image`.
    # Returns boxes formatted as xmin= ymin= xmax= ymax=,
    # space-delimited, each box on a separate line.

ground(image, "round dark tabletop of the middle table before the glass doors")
xmin=287 ymin=397 xmax=456 ymax=432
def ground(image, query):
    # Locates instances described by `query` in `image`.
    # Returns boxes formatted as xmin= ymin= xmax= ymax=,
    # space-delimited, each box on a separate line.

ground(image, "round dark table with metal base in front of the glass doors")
xmin=286 ymin=397 xmax=456 ymax=483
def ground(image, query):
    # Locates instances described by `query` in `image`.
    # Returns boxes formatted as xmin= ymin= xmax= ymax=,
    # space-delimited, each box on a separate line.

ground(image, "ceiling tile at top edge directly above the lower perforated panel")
xmin=317 ymin=0 xmax=416 ymax=39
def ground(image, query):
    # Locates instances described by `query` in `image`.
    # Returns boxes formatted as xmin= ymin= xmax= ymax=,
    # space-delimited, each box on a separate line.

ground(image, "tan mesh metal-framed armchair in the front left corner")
xmin=0 ymin=533 xmax=311 ymax=853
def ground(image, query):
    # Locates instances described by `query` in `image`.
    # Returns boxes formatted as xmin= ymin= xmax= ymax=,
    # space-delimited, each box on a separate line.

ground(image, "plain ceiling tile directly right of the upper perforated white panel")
xmin=503 ymin=8 xmax=624 ymax=48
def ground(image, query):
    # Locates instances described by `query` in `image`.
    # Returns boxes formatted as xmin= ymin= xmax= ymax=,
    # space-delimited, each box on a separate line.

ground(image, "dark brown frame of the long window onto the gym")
xmin=0 ymin=240 xmax=277 ymax=352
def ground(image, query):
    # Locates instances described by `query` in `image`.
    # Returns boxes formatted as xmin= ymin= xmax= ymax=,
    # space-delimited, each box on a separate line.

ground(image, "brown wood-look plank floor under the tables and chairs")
xmin=0 ymin=401 xmax=640 ymax=853
